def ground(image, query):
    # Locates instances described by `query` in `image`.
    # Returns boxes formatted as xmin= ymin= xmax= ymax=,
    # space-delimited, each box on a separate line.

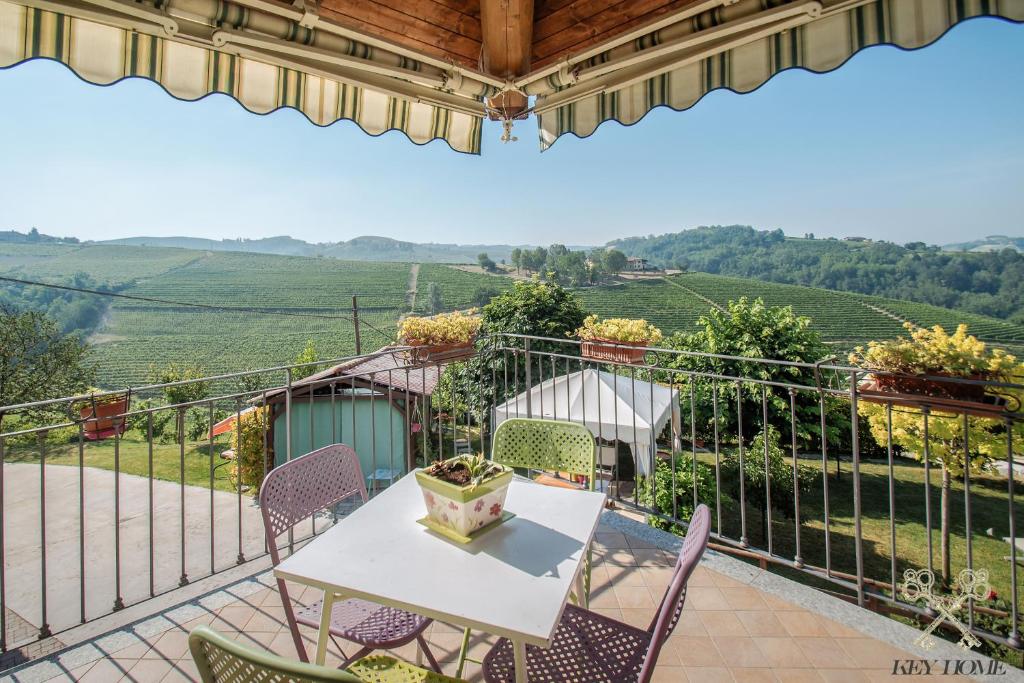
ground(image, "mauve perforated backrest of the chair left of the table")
xmin=259 ymin=443 xmax=367 ymax=564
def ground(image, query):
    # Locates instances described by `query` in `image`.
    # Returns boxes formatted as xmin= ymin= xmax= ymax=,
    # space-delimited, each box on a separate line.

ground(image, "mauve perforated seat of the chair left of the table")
xmin=295 ymin=599 xmax=430 ymax=649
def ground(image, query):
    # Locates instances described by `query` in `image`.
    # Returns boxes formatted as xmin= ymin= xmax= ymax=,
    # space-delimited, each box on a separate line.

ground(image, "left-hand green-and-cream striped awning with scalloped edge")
xmin=0 ymin=0 xmax=496 ymax=154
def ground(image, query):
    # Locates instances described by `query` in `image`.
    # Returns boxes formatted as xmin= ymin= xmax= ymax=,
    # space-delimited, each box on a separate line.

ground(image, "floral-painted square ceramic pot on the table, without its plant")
xmin=416 ymin=467 xmax=513 ymax=537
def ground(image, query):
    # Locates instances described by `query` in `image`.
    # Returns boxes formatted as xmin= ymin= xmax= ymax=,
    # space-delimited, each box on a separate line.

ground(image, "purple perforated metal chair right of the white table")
xmin=483 ymin=505 xmax=711 ymax=683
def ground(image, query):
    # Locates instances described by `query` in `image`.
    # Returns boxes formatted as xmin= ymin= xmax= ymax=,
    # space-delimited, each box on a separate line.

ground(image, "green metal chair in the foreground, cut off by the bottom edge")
xmin=188 ymin=626 xmax=465 ymax=683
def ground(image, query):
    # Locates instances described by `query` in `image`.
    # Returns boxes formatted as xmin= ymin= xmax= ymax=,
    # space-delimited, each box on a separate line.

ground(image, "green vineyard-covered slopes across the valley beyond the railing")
xmin=0 ymin=244 xmax=1024 ymax=387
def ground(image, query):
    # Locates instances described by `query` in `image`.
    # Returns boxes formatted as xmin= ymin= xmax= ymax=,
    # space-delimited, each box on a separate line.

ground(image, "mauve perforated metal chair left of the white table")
xmin=259 ymin=443 xmax=440 ymax=673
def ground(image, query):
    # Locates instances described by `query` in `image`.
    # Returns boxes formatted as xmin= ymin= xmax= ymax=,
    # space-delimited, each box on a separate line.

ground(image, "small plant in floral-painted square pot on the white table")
xmin=416 ymin=455 xmax=513 ymax=539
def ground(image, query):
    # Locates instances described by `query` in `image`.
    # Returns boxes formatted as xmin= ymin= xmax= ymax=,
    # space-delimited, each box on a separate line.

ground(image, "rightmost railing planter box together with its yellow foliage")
xmin=850 ymin=323 xmax=1019 ymax=412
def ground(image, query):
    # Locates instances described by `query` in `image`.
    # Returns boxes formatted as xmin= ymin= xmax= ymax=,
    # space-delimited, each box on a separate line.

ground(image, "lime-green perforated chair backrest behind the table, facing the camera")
xmin=490 ymin=418 xmax=597 ymax=488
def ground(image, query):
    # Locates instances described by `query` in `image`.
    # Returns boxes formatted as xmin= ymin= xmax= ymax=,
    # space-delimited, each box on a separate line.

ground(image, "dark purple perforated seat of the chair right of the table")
xmin=483 ymin=605 xmax=651 ymax=683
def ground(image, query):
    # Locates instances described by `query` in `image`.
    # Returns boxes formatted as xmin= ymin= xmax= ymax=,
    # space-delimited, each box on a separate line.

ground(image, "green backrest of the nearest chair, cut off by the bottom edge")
xmin=188 ymin=626 xmax=361 ymax=683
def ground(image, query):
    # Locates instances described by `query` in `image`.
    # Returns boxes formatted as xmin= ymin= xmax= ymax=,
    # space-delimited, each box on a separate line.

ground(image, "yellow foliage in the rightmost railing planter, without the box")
xmin=850 ymin=323 xmax=1020 ymax=382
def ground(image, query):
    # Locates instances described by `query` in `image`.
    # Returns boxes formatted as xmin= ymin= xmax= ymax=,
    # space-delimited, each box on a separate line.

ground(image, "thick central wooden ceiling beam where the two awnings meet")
xmin=480 ymin=0 xmax=534 ymax=79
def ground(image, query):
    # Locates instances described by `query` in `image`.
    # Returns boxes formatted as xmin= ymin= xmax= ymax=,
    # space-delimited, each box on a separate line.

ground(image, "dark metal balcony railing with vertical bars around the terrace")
xmin=0 ymin=335 xmax=1024 ymax=650
